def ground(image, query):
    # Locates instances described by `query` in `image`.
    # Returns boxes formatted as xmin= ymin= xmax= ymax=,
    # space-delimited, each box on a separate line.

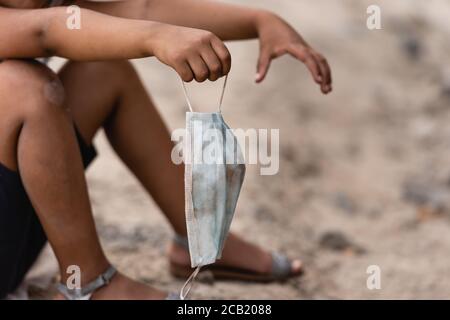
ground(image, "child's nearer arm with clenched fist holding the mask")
xmin=0 ymin=7 xmax=231 ymax=81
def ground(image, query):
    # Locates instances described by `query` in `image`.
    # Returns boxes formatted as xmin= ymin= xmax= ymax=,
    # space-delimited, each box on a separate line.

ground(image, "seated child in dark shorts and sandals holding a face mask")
xmin=0 ymin=0 xmax=332 ymax=299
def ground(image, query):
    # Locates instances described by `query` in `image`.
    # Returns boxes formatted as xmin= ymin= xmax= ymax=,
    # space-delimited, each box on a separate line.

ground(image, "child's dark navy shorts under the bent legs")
xmin=0 ymin=127 xmax=97 ymax=299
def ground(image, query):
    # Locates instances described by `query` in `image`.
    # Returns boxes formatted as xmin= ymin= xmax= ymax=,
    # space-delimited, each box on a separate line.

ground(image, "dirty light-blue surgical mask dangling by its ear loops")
xmin=180 ymin=77 xmax=245 ymax=300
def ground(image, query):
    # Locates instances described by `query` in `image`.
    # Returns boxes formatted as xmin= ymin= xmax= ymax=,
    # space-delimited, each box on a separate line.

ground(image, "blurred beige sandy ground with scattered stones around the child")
xmin=19 ymin=0 xmax=450 ymax=299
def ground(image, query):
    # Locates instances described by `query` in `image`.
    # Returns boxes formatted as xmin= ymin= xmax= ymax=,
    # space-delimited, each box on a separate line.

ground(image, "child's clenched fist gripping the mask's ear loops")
xmin=151 ymin=24 xmax=231 ymax=82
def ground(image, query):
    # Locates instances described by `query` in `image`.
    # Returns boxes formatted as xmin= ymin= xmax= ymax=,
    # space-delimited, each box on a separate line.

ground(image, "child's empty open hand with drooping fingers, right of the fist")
xmin=256 ymin=13 xmax=332 ymax=94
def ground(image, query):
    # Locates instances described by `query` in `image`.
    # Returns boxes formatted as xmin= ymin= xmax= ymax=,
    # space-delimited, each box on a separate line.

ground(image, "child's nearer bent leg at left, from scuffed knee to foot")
xmin=0 ymin=60 xmax=164 ymax=299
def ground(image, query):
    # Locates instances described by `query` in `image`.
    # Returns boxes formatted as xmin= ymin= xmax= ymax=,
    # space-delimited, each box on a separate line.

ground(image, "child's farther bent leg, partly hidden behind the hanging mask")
xmin=60 ymin=62 xmax=295 ymax=273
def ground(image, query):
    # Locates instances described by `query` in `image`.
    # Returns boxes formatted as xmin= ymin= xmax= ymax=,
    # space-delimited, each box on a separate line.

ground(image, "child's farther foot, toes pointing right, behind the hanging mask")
xmin=169 ymin=234 xmax=303 ymax=281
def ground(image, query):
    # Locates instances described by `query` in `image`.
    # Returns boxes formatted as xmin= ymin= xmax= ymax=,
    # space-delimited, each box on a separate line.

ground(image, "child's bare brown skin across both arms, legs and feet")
xmin=0 ymin=0 xmax=331 ymax=299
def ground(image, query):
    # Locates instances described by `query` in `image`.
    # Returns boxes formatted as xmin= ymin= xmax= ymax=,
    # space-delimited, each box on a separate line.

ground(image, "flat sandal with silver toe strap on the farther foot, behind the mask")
xmin=170 ymin=235 xmax=304 ymax=282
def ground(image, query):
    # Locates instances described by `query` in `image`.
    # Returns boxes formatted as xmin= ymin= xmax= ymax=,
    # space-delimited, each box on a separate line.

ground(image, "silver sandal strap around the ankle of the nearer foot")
xmin=57 ymin=266 xmax=117 ymax=300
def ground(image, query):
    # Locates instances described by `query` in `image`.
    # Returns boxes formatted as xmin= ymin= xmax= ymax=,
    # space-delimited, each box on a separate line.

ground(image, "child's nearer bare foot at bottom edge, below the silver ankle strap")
xmin=55 ymin=273 xmax=167 ymax=300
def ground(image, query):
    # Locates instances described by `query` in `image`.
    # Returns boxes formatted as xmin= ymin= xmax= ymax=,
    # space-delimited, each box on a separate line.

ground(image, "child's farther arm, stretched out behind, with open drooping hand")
xmin=78 ymin=0 xmax=332 ymax=93
